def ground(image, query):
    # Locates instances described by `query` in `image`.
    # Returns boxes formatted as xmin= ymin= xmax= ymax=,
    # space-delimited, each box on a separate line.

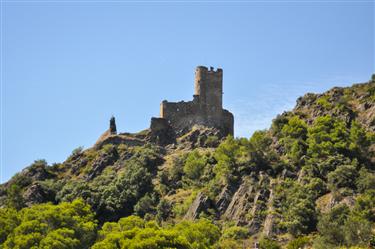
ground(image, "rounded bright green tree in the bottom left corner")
xmin=3 ymin=200 xmax=96 ymax=249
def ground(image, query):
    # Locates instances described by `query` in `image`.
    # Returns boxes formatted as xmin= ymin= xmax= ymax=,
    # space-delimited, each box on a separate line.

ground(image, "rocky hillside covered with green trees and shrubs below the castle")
xmin=0 ymin=76 xmax=375 ymax=248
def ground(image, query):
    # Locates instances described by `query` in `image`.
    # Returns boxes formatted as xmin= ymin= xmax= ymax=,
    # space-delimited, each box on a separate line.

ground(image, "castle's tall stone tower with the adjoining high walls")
xmin=160 ymin=66 xmax=234 ymax=136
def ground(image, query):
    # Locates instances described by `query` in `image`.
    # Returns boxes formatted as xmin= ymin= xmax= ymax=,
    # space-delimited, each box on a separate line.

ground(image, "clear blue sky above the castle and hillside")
xmin=0 ymin=0 xmax=375 ymax=182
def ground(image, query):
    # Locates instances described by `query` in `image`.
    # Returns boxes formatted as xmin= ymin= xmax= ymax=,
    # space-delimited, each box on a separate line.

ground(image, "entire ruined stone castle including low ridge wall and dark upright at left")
xmin=94 ymin=66 xmax=234 ymax=148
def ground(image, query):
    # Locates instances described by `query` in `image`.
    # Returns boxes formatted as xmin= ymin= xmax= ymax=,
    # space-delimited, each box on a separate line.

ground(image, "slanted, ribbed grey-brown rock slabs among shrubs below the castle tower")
xmin=185 ymin=174 xmax=274 ymax=235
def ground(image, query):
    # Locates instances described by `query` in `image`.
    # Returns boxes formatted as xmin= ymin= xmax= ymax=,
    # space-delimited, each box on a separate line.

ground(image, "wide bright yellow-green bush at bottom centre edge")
xmin=92 ymin=216 xmax=220 ymax=249
